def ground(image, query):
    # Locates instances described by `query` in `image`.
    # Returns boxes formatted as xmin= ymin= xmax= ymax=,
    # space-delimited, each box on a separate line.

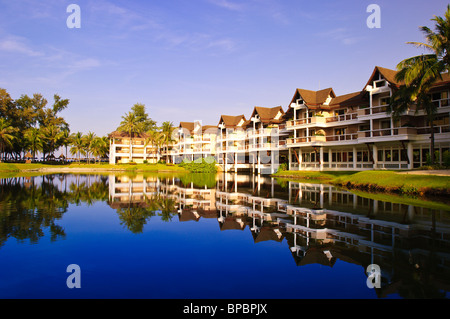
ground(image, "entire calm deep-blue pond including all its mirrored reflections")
xmin=0 ymin=175 xmax=450 ymax=299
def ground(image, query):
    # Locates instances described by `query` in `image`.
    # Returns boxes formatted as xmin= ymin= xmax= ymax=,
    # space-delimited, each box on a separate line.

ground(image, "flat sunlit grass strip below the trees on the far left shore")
xmin=0 ymin=163 xmax=186 ymax=172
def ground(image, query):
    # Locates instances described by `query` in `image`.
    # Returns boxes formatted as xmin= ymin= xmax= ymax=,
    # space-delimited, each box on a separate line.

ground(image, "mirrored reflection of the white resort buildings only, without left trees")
xmin=109 ymin=174 xmax=450 ymax=298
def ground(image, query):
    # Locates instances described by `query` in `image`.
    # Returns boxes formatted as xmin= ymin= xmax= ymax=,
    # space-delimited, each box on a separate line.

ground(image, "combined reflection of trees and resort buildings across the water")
xmin=0 ymin=174 xmax=450 ymax=298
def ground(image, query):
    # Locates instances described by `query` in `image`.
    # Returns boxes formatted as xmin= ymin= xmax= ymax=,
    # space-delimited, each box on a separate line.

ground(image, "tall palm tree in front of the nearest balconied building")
xmin=388 ymin=5 xmax=450 ymax=164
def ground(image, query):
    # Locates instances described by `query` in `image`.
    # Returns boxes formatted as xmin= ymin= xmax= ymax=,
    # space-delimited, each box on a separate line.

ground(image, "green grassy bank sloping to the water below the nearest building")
xmin=274 ymin=171 xmax=450 ymax=196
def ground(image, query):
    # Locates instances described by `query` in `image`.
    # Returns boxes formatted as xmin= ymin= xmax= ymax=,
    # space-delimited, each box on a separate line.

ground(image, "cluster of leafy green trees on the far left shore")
xmin=0 ymin=88 xmax=109 ymax=161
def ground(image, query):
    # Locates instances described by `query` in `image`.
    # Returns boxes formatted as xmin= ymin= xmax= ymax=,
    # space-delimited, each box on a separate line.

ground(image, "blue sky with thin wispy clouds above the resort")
xmin=0 ymin=0 xmax=448 ymax=135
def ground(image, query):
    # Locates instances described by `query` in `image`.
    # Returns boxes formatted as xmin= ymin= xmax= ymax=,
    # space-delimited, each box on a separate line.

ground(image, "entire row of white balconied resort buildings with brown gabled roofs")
xmin=110 ymin=66 xmax=450 ymax=174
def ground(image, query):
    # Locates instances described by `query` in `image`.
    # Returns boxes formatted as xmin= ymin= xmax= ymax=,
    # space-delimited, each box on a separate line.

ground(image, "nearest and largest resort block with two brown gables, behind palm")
xmin=286 ymin=67 xmax=450 ymax=170
